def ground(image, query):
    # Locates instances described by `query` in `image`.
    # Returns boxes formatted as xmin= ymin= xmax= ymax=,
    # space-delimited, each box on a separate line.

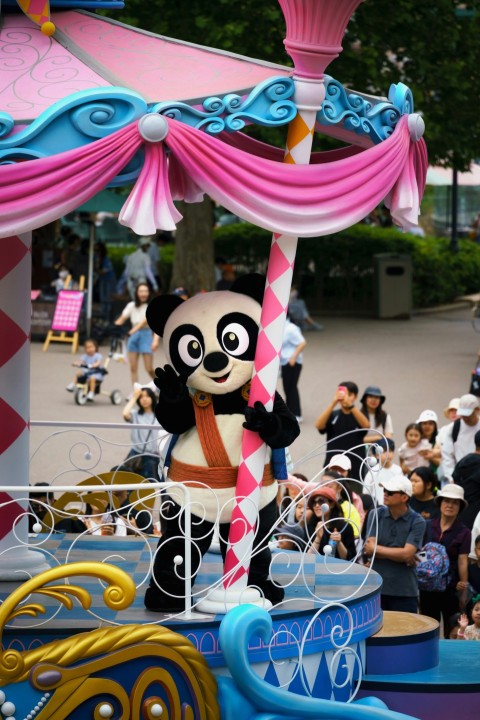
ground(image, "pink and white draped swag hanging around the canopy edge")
xmin=0 ymin=111 xmax=426 ymax=237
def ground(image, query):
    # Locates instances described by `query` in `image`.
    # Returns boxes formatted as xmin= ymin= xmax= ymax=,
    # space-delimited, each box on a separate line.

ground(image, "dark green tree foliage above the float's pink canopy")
xmin=111 ymin=0 xmax=480 ymax=170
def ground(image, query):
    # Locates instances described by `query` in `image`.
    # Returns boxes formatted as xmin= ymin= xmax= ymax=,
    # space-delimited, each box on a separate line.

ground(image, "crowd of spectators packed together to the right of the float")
xmin=277 ymin=381 xmax=480 ymax=639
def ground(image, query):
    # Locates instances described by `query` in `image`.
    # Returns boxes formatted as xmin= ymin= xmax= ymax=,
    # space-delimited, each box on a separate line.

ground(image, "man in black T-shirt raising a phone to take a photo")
xmin=315 ymin=381 xmax=370 ymax=489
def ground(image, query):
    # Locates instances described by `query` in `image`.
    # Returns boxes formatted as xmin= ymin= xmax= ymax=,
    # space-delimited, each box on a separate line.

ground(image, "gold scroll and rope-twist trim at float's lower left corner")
xmin=0 ymin=563 xmax=220 ymax=720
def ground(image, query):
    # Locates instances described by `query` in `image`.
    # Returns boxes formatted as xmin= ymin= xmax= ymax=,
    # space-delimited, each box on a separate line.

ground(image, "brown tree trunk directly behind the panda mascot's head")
xmin=171 ymin=198 xmax=215 ymax=295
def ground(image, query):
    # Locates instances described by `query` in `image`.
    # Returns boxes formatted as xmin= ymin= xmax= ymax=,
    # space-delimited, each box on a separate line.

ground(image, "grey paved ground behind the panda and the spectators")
xmin=31 ymin=307 xmax=480 ymax=484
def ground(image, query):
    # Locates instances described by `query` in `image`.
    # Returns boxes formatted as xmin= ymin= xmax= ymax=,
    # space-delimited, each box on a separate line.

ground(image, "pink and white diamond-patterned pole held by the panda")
xmin=220 ymin=0 xmax=363 ymax=609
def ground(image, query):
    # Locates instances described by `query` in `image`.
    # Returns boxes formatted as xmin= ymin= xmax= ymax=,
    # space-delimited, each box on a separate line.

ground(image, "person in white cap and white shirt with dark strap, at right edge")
xmin=442 ymin=393 xmax=480 ymax=482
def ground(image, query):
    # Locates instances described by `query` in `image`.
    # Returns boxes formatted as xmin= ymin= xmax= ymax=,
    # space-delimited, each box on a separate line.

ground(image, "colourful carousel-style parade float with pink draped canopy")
xmin=0 ymin=0 xmax=480 ymax=720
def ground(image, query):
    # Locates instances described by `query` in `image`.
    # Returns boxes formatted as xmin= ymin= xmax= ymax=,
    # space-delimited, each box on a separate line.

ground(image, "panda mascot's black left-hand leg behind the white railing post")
xmin=144 ymin=504 xmax=214 ymax=612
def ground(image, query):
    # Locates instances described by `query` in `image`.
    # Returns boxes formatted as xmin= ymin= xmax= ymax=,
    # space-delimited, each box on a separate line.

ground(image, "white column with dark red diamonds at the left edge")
xmin=0 ymin=233 xmax=49 ymax=581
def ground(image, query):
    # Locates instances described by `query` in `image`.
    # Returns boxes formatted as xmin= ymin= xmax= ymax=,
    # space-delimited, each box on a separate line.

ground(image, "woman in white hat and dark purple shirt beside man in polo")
xmin=420 ymin=483 xmax=471 ymax=637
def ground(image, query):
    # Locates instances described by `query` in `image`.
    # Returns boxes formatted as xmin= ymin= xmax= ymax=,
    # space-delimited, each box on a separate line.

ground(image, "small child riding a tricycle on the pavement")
xmin=66 ymin=338 xmax=122 ymax=405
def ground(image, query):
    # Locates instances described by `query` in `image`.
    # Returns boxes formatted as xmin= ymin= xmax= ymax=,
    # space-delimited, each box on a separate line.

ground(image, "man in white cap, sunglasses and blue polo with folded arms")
xmin=363 ymin=475 xmax=425 ymax=613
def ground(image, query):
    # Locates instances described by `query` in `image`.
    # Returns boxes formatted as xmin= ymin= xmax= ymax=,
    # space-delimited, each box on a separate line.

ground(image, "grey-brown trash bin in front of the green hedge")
xmin=373 ymin=253 xmax=412 ymax=318
